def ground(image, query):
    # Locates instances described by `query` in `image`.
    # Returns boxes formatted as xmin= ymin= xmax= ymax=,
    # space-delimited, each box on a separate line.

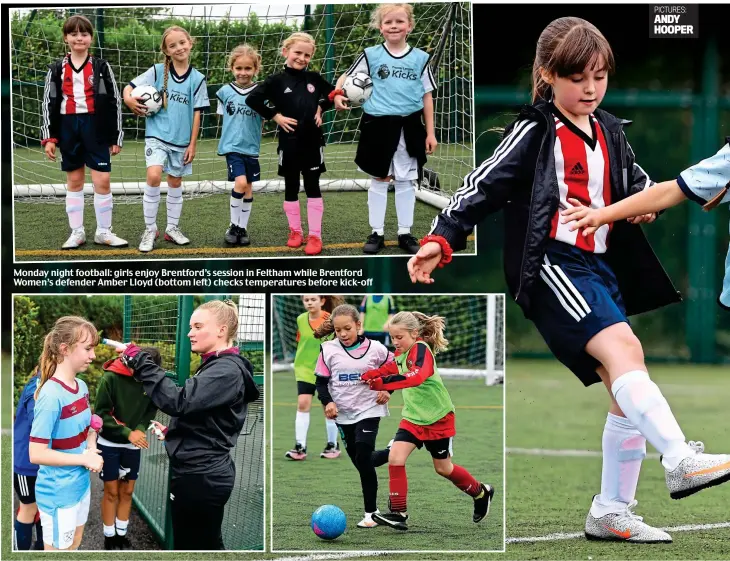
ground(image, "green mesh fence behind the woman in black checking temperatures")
xmin=124 ymin=295 xmax=265 ymax=550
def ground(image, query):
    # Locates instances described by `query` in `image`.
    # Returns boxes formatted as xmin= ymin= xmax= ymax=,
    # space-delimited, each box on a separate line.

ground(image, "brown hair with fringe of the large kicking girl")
xmin=532 ymin=17 xmax=615 ymax=103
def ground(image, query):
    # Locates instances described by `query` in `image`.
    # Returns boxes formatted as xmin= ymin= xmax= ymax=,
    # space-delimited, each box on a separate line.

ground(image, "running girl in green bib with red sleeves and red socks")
xmin=361 ymin=312 xmax=494 ymax=530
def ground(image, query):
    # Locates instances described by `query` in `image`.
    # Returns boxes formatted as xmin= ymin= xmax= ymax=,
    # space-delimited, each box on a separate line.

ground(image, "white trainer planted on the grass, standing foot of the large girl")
xmin=585 ymin=501 xmax=672 ymax=543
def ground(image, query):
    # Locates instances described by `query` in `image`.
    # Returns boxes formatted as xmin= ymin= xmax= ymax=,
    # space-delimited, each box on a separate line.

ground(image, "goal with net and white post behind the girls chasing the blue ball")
xmin=272 ymin=294 xmax=504 ymax=385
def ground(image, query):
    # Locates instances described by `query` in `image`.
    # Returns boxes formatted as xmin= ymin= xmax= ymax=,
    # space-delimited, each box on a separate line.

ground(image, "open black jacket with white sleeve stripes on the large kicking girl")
xmin=431 ymin=101 xmax=681 ymax=318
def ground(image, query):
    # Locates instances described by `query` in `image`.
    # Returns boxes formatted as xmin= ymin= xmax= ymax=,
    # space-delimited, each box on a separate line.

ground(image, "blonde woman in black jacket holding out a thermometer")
xmin=122 ymin=300 xmax=259 ymax=550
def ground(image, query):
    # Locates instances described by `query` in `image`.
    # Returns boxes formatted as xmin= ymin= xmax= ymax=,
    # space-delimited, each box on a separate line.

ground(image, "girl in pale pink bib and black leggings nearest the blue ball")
xmin=315 ymin=304 xmax=392 ymax=528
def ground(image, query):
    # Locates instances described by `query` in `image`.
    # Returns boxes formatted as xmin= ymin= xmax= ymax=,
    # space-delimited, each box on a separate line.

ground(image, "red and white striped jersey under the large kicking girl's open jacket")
xmin=550 ymin=115 xmax=613 ymax=253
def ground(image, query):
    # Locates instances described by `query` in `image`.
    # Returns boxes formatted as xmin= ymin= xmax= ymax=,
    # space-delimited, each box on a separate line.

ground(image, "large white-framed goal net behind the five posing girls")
xmin=11 ymin=2 xmax=474 ymax=206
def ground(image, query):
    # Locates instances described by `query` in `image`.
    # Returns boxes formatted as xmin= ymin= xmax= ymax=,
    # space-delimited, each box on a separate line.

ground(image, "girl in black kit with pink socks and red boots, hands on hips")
xmin=246 ymin=33 xmax=335 ymax=255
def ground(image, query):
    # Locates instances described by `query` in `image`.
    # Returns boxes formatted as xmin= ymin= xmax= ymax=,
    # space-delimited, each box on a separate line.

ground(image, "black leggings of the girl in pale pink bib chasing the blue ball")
xmin=337 ymin=417 xmax=380 ymax=512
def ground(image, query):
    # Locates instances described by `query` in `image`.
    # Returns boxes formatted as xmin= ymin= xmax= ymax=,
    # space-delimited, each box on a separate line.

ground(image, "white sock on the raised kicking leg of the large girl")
xmin=611 ymin=370 xmax=694 ymax=471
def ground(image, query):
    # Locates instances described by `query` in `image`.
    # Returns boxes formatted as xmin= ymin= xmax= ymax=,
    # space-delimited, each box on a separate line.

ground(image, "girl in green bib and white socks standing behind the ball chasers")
xmin=285 ymin=294 xmax=344 ymax=461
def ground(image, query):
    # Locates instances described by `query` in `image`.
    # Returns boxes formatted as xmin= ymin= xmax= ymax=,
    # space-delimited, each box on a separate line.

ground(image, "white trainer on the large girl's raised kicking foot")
xmin=665 ymin=440 xmax=730 ymax=499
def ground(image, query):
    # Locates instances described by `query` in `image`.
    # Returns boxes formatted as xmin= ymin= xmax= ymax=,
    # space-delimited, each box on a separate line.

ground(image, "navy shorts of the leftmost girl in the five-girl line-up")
xmin=58 ymin=113 xmax=112 ymax=172
